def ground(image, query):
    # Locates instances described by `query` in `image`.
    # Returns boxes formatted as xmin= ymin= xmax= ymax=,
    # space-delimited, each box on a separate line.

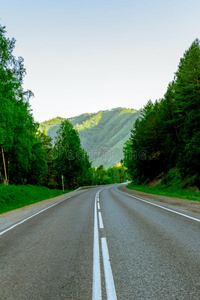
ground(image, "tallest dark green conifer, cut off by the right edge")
xmin=174 ymin=39 xmax=200 ymax=173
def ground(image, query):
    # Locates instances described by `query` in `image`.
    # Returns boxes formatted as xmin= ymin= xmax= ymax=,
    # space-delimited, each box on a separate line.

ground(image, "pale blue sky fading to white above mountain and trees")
xmin=0 ymin=0 xmax=200 ymax=122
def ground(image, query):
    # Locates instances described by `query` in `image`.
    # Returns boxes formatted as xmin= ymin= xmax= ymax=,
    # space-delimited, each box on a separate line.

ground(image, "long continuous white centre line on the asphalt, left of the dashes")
xmin=92 ymin=194 xmax=101 ymax=300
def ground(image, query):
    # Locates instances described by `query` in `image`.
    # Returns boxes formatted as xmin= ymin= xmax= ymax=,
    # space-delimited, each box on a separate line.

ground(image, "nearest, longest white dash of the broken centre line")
xmin=101 ymin=237 xmax=117 ymax=300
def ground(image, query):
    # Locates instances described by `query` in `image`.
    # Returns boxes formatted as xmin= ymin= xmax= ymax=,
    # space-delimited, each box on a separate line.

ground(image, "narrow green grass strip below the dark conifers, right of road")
xmin=127 ymin=183 xmax=200 ymax=201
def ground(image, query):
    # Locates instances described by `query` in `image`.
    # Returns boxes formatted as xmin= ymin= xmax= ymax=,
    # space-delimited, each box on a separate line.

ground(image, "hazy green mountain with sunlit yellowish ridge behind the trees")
xmin=39 ymin=107 xmax=140 ymax=169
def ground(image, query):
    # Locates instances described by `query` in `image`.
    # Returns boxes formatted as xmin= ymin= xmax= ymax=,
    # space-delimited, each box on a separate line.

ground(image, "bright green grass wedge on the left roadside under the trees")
xmin=0 ymin=184 xmax=69 ymax=214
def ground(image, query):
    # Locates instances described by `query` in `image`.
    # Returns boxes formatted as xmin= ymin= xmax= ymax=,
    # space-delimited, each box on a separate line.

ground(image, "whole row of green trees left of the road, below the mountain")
xmin=0 ymin=25 xmax=126 ymax=189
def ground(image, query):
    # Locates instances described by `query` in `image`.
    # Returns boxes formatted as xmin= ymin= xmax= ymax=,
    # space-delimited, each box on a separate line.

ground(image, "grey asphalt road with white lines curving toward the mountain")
xmin=0 ymin=186 xmax=200 ymax=300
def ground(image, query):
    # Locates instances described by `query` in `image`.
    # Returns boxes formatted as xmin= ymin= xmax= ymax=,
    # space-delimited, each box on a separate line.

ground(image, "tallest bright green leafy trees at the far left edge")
xmin=0 ymin=25 xmax=46 ymax=184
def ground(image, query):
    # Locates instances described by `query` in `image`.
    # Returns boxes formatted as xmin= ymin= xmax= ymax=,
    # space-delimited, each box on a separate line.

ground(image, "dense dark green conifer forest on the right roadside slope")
xmin=124 ymin=39 xmax=200 ymax=187
